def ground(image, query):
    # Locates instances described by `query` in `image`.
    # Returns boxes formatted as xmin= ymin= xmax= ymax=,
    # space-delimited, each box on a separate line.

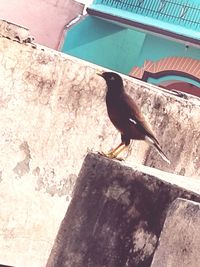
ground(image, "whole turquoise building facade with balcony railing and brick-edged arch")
xmin=62 ymin=0 xmax=200 ymax=96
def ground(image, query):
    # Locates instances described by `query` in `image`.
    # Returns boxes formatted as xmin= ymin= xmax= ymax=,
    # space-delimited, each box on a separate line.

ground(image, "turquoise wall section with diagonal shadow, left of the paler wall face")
xmin=62 ymin=16 xmax=145 ymax=74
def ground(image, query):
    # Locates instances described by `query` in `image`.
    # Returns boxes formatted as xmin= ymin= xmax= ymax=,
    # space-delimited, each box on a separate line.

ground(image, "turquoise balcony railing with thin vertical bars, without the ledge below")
xmin=94 ymin=0 xmax=200 ymax=31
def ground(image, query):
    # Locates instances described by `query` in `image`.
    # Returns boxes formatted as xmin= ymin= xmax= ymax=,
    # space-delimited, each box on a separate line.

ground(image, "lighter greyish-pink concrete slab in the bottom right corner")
xmin=151 ymin=199 xmax=200 ymax=267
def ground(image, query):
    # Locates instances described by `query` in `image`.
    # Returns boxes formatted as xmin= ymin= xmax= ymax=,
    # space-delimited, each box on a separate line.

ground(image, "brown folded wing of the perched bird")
xmin=124 ymin=94 xmax=158 ymax=144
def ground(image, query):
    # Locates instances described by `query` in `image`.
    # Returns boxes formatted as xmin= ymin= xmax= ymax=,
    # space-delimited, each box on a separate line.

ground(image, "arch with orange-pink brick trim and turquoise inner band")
xmin=130 ymin=57 xmax=200 ymax=97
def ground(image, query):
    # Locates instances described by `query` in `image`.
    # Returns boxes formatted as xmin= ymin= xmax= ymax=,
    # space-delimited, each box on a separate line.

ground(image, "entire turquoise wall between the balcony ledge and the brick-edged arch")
xmin=62 ymin=16 xmax=200 ymax=79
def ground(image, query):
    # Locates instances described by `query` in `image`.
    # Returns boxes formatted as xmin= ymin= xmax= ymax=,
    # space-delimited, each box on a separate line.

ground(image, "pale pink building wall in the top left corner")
xmin=0 ymin=0 xmax=83 ymax=49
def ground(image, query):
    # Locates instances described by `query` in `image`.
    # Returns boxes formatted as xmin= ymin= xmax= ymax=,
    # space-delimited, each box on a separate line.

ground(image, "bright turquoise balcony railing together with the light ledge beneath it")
xmin=90 ymin=0 xmax=200 ymax=40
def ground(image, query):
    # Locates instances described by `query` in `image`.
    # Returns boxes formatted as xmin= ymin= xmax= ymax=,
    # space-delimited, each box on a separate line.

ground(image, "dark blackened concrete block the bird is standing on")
xmin=47 ymin=154 xmax=200 ymax=267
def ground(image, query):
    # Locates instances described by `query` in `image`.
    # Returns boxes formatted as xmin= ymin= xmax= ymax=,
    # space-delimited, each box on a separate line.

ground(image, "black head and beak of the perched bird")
xmin=97 ymin=72 xmax=123 ymax=91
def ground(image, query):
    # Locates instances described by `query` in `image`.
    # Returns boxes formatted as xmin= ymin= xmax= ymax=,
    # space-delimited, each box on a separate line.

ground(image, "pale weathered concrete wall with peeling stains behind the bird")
xmin=0 ymin=28 xmax=200 ymax=267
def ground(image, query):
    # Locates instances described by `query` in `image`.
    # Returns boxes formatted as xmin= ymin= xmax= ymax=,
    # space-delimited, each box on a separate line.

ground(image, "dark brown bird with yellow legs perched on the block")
xmin=97 ymin=72 xmax=170 ymax=163
